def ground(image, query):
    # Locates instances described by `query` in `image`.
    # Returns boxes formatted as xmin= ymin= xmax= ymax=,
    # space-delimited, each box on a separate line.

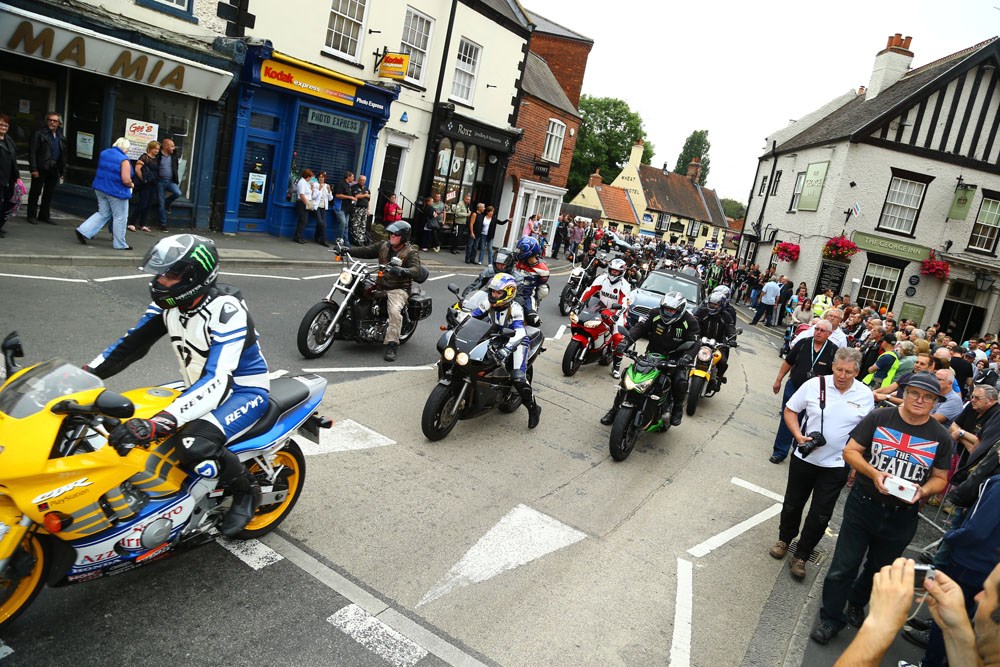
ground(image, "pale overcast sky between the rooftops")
xmin=522 ymin=0 xmax=1000 ymax=204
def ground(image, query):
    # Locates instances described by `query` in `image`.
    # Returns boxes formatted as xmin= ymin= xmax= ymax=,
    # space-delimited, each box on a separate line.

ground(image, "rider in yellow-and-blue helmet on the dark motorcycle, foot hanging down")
xmin=469 ymin=273 xmax=542 ymax=429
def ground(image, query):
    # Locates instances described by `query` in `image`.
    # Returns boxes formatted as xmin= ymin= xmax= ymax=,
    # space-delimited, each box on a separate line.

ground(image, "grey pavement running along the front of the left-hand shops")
xmin=0 ymin=206 xmax=570 ymax=274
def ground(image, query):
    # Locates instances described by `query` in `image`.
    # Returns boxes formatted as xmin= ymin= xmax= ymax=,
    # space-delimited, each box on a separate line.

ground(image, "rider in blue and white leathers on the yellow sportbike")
xmin=85 ymin=234 xmax=270 ymax=537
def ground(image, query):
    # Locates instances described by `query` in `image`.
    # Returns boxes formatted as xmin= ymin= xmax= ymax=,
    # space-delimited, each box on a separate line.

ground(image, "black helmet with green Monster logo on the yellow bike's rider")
xmin=139 ymin=234 xmax=219 ymax=310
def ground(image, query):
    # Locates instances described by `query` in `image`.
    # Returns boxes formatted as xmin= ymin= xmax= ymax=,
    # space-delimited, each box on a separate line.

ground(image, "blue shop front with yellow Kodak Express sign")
xmin=222 ymin=45 xmax=399 ymax=238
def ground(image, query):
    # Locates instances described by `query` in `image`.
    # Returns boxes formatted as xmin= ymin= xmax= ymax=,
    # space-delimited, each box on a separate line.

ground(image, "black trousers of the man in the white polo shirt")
xmin=778 ymin=455 xmax=851 ymax=560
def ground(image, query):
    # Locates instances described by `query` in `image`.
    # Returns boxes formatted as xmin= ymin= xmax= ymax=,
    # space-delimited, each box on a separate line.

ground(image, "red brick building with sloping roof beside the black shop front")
xmin=500 ymin=12 xmax=594 ymax=246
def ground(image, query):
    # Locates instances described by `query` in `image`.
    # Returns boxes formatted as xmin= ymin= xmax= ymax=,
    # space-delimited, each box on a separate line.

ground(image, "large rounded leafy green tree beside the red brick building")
xmin=566 ymin=95 xmax=655 ymax=201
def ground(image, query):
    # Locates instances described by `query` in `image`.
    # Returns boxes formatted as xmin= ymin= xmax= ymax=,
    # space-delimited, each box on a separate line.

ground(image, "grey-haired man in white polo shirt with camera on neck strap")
xmin=769 ymin=347 xmax=875 ymax=580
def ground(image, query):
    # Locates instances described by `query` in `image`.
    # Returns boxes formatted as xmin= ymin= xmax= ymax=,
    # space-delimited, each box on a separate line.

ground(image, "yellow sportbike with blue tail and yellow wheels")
xmin=0 ymin=334 xmax=330 ymax=628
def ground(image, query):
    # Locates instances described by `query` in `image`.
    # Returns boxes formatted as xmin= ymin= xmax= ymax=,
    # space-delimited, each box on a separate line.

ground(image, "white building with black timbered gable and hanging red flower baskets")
xmin=739 ymin=34 xmax=1000 ymax=339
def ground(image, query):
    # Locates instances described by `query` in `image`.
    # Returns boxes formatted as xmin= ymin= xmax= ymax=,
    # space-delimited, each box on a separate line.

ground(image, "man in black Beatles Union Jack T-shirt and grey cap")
xmin=809 ymin=373 xmax=952 ymax=644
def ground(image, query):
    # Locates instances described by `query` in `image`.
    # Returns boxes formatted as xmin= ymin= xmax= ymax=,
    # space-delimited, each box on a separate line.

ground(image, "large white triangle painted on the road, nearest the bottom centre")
xmin=417 ymin=505 xmax=587 ymax=607
